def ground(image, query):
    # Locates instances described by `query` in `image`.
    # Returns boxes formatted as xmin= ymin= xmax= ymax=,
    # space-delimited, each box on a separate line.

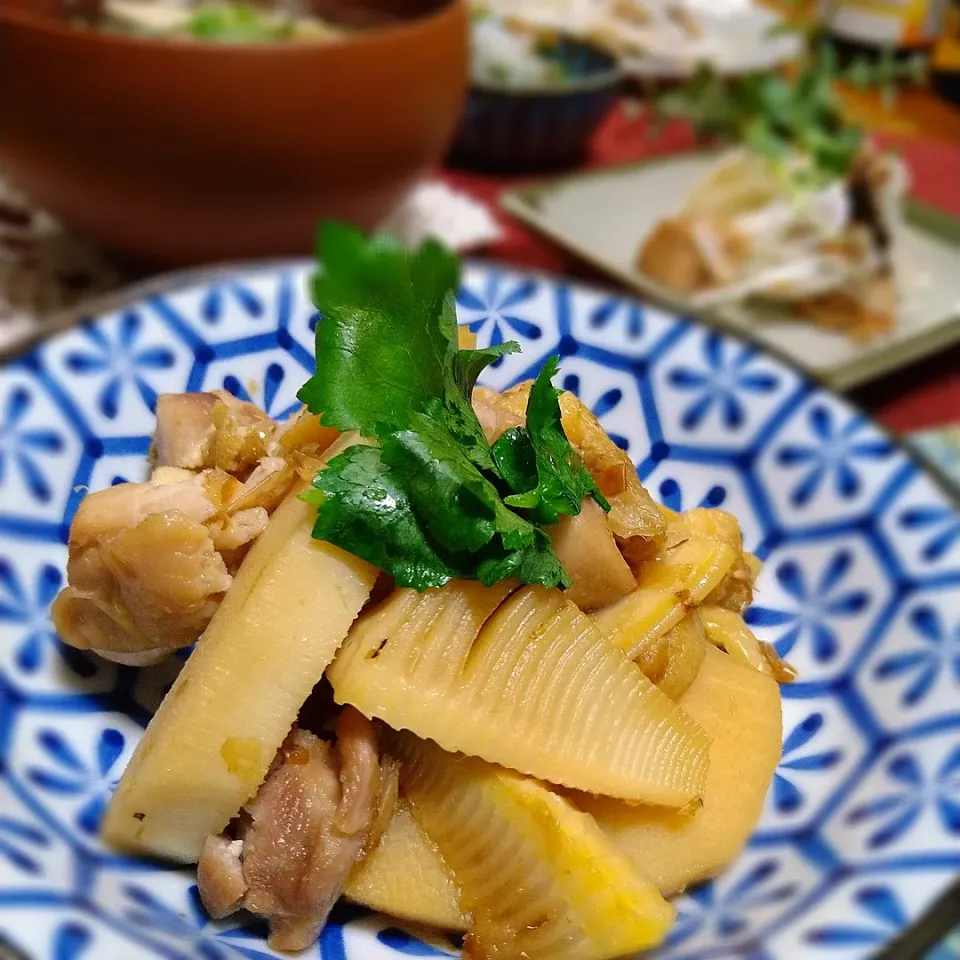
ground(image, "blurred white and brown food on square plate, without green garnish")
xmin=637 ymin=142 xmax=906 ymax=340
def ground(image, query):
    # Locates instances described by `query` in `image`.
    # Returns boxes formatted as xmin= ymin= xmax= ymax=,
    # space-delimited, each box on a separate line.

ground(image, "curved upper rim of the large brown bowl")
xmin=0 ymin=0 xmax=467 ymax=57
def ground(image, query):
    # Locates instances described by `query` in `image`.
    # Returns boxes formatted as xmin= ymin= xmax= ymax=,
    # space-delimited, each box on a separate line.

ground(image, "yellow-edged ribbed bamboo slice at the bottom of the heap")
xmin=391 ymin=734 xmax=674 ymax=960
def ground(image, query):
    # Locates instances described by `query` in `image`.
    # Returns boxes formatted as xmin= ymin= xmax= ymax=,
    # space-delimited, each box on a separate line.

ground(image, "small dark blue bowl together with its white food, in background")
xmin=451 ymin=16 xmax=623 ymax=171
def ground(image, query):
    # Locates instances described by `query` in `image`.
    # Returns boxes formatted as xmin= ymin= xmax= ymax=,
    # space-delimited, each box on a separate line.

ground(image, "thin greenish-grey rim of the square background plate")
xmin=499 ymin=147 xmax=960 ymax=397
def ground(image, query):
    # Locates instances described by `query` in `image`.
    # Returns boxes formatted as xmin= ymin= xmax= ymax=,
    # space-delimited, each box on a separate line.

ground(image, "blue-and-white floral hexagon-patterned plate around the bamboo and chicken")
xmin=0 ymin=264 xmax=960 ymax=960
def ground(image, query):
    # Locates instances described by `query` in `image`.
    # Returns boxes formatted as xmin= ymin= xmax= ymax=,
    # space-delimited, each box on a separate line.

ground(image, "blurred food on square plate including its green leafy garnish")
xmin=636 ymin=42 xmax=915 ymax=341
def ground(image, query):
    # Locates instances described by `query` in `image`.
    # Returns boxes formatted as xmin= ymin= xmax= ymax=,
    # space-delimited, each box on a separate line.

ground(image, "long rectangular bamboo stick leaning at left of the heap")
xmin=103 ymin=438 xmax=377 ymax=863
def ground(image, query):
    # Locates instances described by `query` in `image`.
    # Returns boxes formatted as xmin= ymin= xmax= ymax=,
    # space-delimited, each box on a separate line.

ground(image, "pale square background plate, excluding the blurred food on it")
xmin=501 ymin=154 xmax=960 ymax=389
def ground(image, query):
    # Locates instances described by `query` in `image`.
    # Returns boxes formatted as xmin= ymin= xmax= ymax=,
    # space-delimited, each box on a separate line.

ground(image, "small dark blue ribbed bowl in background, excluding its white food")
xmin=450 ymin=26 xmax=623 ymax=172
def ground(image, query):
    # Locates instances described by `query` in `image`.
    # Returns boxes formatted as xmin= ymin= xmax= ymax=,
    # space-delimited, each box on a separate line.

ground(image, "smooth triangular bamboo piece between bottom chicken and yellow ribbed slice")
xmin=344 ymin=803 xmax=470 ymax=931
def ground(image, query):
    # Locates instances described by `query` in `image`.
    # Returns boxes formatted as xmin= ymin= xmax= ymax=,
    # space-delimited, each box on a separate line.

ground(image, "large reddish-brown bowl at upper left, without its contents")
xmin=0 ymin=0 xmax=468 ymax=266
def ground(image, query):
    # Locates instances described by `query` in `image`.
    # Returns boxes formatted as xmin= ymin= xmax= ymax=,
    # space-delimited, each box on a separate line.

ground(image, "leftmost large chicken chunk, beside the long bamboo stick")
xmin=52 ymin=464 xmax=284 ymax=665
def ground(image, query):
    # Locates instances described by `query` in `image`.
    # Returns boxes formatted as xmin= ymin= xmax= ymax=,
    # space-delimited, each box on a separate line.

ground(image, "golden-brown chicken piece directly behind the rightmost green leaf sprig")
xmin=473 ymin=381 xmax=666 ymax=569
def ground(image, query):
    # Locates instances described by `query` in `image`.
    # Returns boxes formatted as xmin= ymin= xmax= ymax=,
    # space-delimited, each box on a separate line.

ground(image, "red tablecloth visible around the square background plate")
xmin=442 ymin=104 xmax=960 ymax=431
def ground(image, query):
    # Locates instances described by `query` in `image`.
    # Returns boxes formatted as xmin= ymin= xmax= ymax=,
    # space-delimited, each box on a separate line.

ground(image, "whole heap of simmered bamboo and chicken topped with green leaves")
xmin=54 ymin=225 xmax=790 ymax=960
